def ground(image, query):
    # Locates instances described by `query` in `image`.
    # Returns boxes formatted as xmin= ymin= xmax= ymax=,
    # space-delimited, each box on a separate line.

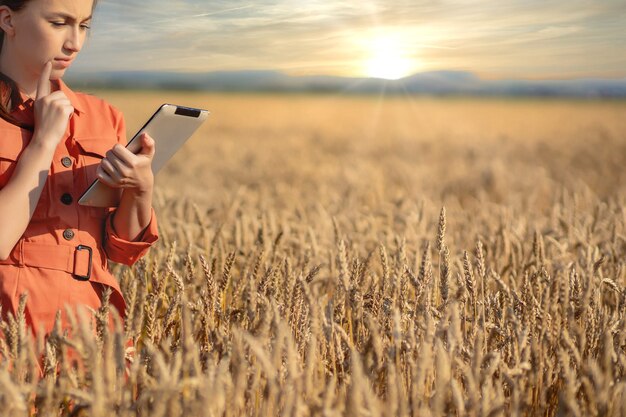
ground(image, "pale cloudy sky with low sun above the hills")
xmin=72 ymin=0 xmax=626 ymax=79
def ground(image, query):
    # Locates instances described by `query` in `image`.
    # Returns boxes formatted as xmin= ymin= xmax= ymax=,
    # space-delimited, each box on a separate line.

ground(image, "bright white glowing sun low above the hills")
xmin=363 ymin=35 xmax=415 ymax=80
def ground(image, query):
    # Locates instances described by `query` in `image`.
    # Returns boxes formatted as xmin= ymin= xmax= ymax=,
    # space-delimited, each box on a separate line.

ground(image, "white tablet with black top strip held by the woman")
xmin=78 ymin=104 xmax=209 ymax=207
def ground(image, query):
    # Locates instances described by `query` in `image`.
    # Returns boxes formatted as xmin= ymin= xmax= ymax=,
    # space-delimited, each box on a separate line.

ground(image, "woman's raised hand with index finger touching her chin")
xmin=33 ymin=61 xmax=74 ymax=150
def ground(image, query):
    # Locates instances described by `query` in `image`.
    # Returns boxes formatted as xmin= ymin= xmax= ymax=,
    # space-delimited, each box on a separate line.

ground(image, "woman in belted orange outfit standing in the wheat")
xmin=0 ymin=0 xmax=158 ymax=344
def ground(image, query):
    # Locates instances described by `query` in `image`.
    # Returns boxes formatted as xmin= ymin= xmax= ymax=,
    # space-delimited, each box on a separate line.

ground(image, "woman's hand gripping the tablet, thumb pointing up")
xmin=96 ymin=133 xmax=154 ymax=194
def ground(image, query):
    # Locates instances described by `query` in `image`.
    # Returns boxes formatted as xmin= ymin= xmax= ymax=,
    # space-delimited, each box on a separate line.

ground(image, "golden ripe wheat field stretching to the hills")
xmin=0 ymin=91 xmax=626 ymax=417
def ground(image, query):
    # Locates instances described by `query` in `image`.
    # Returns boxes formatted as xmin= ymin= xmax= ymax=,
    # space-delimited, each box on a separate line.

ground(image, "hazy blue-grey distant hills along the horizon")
xmin=67 ymin=70 xmax=626 ymax=98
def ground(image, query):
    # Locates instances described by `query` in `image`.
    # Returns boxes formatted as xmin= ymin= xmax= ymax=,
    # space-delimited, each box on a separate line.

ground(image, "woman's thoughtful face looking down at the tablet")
xmin=2 ymin=0 xmax=93 ymax=79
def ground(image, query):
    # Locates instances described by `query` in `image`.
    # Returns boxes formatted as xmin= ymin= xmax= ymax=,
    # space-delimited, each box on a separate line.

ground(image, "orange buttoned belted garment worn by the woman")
xmin=0 ymin=80 xmax=158 ymax=334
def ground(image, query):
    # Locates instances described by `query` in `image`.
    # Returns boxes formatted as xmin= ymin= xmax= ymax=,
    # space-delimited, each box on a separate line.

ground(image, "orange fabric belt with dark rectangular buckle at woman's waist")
xmin=0 ymin=240 xmax=101 ymax=281
